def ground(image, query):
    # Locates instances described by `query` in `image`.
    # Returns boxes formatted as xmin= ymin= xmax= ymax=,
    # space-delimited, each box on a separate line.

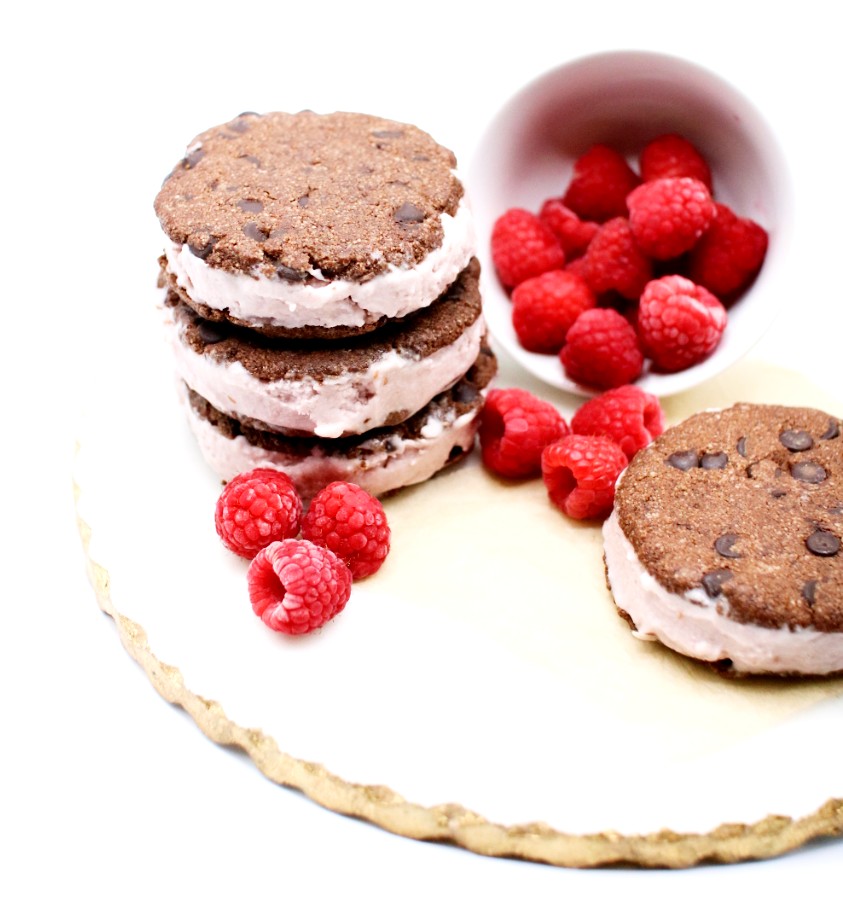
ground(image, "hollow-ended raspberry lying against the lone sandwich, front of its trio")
xmin=542 ymin=435 xmax=628 ymax=520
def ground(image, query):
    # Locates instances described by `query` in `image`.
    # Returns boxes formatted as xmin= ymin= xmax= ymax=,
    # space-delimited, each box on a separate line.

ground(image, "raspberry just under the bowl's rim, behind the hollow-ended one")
xmin=571 ymin=384 xmax=664 ymax=460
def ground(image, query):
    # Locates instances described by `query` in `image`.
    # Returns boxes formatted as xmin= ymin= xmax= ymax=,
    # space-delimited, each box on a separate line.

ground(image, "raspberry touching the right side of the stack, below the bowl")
xmin=480 ymin=387 xmax=568 ymax=479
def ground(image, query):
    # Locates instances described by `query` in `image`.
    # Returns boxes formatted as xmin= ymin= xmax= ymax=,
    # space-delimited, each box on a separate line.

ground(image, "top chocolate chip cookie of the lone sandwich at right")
xmin=616 ymin=404 xmax=843 ymax=632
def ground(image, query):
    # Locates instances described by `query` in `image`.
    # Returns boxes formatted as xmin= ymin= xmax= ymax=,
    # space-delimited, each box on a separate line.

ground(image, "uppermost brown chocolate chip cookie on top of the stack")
xmin=155 ymin=111 xmax=463 ymax=282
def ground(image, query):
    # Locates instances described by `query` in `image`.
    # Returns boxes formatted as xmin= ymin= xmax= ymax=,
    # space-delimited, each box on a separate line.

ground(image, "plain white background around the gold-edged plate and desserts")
xmin=0 ymin=0 xmax=843 ymax=911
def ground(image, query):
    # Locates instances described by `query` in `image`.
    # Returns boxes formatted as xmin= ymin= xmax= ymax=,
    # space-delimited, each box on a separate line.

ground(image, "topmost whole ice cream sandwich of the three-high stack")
xmin=155 ymin=111 xmax=474 ymax=330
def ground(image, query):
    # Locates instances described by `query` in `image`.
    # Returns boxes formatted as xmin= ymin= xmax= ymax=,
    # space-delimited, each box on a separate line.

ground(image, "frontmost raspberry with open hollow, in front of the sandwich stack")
xmin=247 ymin=539 xmax=351 ymax=635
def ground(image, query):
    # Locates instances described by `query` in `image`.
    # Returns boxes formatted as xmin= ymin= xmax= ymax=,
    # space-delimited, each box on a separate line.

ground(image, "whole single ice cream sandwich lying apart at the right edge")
xmin=603 ymin=404 xmax=843 ymax=675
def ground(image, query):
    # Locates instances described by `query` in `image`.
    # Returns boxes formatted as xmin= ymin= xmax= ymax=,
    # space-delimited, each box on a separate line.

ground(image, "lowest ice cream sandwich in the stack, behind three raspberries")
xmin=179 ymin=347 xmax=497 ymax=500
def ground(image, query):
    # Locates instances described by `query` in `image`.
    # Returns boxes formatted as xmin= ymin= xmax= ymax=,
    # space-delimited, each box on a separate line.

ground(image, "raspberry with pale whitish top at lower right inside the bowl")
xmin=638 ymin=276 xmax=726 ymax=371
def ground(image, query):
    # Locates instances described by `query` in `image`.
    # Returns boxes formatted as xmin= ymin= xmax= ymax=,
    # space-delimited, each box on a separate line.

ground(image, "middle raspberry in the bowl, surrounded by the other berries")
xmin=584 ymin=216 xmax=653 ymax=299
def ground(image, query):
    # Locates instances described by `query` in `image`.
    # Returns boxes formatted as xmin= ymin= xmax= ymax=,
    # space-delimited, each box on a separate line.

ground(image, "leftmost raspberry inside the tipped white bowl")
xmin=492 ymin=209 xmax=565 ymax=288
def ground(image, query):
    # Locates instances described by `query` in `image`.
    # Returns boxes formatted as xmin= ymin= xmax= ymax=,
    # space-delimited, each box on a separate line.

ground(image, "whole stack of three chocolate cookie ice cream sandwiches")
xmin=155 ymin=112 xmax=496 ymax=497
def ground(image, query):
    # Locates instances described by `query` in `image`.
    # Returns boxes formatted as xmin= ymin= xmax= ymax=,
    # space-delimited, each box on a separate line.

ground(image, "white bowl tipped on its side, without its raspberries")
xmin=467 ymin=51 xmax=792 ymax=396
